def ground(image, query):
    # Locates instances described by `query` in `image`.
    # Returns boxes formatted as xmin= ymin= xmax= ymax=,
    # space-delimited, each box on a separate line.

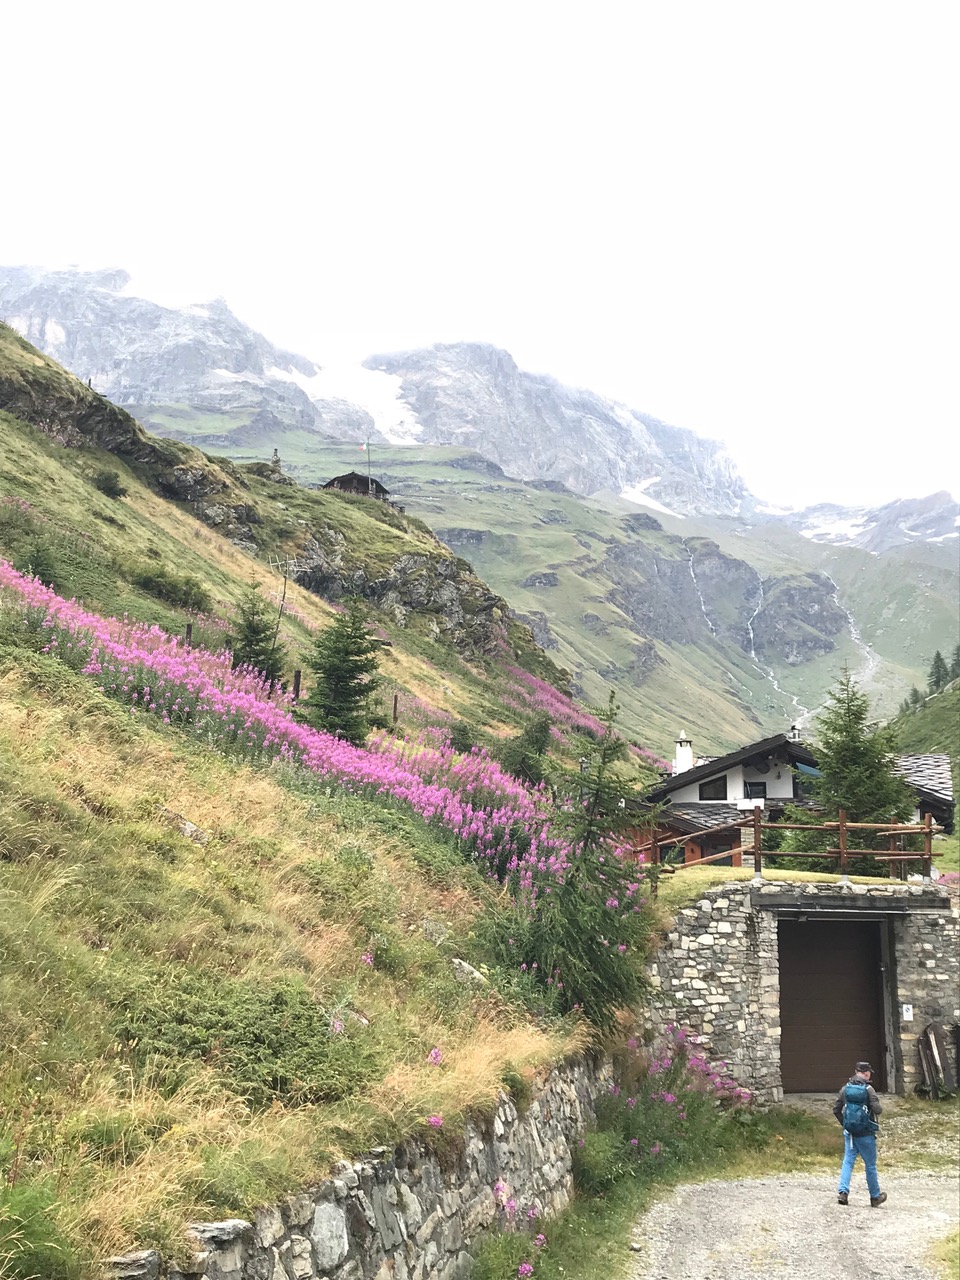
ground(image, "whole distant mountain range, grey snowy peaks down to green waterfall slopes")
xmin=0 ymin=268 xmax=960 ymax=750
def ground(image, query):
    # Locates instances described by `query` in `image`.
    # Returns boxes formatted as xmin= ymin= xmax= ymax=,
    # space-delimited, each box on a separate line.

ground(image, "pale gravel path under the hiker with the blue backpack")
xmin=631 ymin=1165 xmax=960 ymax=1280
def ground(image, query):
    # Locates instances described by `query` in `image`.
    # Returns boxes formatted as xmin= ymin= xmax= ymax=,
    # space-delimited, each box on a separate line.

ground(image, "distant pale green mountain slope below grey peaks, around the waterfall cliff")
xmin=193 ymin=433 xmax=829 ymax=754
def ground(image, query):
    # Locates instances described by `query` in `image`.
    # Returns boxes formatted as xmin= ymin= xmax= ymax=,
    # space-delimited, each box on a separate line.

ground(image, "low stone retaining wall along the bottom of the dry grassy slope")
xmin=108 ymin=1062 xmax=611 ymax=1280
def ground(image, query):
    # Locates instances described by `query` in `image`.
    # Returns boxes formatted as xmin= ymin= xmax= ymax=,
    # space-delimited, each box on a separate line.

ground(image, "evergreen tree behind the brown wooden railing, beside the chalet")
xmin=781 ymin=671 xmax=915 ymax=876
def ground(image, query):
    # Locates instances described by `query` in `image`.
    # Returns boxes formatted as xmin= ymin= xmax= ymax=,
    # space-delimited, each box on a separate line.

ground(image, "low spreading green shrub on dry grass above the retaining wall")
xmin=116 ymin=973 xmax=384 ymax=1107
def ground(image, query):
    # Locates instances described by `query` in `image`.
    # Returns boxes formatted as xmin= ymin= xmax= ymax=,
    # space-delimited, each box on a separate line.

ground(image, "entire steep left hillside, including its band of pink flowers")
xmin=0 ymin=328 xmax=670 ymax=1280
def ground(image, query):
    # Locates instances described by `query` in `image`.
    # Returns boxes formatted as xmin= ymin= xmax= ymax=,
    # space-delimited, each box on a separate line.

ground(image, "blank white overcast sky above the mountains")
xmin=0 ymin=0 xmax=960 ymax=504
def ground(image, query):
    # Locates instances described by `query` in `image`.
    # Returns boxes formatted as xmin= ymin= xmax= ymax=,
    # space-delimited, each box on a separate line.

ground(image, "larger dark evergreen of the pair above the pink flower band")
xmin=300 ymin=599 xmax=380 ymax=746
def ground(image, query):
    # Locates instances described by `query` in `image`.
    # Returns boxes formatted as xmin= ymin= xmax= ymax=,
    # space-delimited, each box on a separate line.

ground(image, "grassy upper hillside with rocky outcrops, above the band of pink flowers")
xmin=0 ymin=326 xmax=578 ymax=742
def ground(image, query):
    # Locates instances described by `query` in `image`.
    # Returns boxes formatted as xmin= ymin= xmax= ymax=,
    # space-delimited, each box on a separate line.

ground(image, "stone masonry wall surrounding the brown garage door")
xmin=646 ymin=872 xmax=960 ymax=1102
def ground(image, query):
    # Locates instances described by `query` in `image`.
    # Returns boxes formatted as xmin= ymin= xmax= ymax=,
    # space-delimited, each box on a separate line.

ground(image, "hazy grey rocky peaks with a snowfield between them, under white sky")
xmin=0 ymin=268 xmax=746 ymax=516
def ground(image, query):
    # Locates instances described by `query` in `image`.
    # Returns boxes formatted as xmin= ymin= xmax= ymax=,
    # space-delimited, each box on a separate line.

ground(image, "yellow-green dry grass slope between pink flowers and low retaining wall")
xmin=0 ymin=645 xmax=567 ymax=1264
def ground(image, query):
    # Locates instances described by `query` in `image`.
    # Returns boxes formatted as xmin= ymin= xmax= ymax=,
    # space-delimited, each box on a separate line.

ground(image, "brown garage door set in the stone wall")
xmin=778 ymin=920 xmax=887 ymax=1093
